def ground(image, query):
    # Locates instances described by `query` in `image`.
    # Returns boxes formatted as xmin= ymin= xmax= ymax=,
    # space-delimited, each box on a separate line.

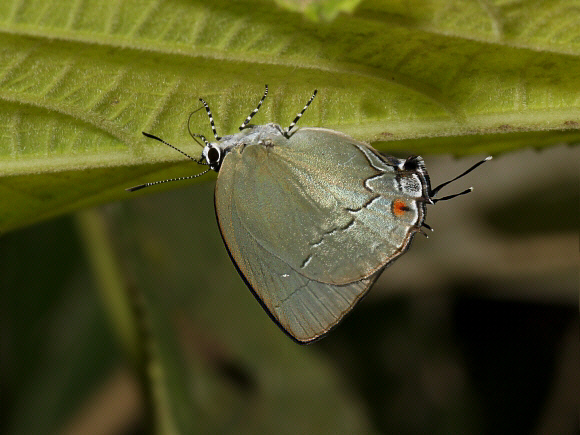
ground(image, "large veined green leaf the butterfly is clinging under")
xmin=0 ymin=0 xmax=580 ymax=232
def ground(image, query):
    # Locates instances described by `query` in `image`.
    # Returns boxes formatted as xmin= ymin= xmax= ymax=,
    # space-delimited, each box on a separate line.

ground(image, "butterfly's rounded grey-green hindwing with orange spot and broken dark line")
xmin=224 ymin=129 xmax=423 ymax=285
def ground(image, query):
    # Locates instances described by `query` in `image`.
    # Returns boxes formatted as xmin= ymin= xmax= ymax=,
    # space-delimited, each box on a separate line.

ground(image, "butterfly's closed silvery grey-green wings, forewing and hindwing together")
xmin=215 ymin=127 xmax=425 ymax=342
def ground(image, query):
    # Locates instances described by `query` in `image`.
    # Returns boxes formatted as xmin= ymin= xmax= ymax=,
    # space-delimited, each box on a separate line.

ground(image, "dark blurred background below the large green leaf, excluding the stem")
xmin=0 ymin=146 xmax=580 ymax=434
